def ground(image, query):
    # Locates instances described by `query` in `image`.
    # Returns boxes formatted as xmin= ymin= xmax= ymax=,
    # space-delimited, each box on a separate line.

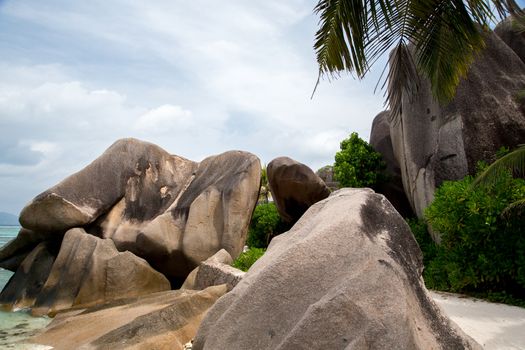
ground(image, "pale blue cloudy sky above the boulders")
xmin=0 ymin=0 xmax=383 ymax=214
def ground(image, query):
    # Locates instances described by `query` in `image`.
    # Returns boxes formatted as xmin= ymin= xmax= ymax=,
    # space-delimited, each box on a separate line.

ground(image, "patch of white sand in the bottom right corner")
xmin=430 ymin=291 xmax=525 ymax=350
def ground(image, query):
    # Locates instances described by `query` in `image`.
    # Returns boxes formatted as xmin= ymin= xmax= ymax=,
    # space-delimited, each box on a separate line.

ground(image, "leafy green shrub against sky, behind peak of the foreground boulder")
xmin=334 ymin=132 xmax=386 ymax=188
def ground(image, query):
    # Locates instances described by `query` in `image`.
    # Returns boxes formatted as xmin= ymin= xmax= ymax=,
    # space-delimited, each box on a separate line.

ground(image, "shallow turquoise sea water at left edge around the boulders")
xmin=0 ymin=226 xmax=50 ymax=349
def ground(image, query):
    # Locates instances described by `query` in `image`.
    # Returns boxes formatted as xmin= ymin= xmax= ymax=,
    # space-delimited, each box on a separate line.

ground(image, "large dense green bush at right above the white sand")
xmin=422 ymin=164 xmax=525 ymax=302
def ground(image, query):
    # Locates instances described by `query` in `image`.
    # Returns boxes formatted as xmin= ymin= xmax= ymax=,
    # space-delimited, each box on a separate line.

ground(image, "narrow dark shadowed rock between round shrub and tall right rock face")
xmin=370 ymin=111 xmax=414 ymax=217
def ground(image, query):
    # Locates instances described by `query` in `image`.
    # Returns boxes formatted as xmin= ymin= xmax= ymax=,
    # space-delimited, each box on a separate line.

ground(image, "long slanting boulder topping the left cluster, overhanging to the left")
xmin=20 ymin=139 xmax=197 ymax=233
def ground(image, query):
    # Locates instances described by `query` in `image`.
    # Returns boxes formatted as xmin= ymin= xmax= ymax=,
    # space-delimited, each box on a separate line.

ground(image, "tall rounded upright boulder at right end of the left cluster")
xmin=126 ymin=151 xmax=261 ymax=282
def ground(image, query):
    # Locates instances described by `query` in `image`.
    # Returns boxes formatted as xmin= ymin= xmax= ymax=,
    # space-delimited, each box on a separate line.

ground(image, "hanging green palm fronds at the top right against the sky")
xmin=314 ymin=0 xmax=525 ymax=114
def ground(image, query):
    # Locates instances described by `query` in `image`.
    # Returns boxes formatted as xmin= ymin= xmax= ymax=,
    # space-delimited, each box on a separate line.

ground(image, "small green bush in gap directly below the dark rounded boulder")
xmin=246 ymin=203 xmax=285 ymax=248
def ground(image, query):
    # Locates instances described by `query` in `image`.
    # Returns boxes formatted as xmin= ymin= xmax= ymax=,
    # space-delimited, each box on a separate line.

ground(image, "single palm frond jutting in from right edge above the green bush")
xmin=472 ymin=145 xmax=525 ymax=187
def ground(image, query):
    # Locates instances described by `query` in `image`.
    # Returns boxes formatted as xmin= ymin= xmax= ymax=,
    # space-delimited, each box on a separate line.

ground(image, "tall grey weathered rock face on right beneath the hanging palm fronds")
xmin=390 ymin=32 xmax=525 ymax=217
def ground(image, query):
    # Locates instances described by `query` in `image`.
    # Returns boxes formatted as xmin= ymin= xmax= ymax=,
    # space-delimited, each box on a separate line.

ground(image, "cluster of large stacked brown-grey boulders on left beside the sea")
xmin=0 ymin=139 xmax=261 ymax=314
